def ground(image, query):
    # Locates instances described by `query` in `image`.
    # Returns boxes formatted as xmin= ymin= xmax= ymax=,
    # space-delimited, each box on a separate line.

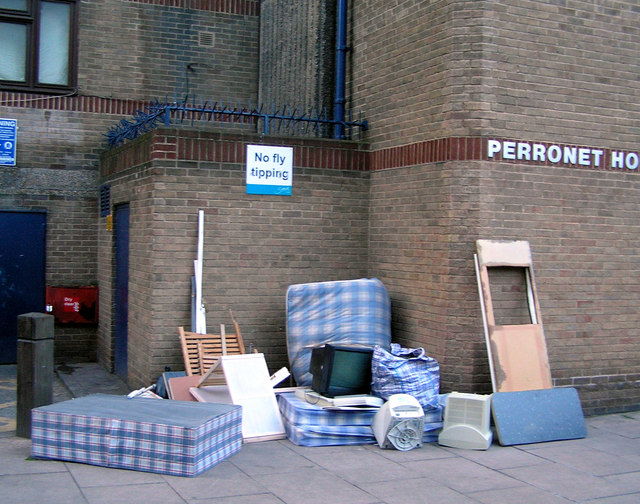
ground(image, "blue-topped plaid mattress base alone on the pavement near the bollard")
xmin=31 ymin=394 xmax=242 ymax=476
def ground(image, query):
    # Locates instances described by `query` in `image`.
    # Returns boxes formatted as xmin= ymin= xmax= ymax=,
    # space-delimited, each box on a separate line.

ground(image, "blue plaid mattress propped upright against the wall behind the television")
xmin=286 ymin=278 xmax=391 ymax=386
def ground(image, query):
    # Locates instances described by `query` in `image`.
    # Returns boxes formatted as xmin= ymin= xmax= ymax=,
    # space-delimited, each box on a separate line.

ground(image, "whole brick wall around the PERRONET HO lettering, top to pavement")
xmin=350 ymin=0 xmax=640 ymax=413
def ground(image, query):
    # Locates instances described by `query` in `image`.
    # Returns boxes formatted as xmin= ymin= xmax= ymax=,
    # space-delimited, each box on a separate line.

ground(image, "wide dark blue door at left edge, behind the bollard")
xmin=0 ymin=211 xmax=47 ymax=364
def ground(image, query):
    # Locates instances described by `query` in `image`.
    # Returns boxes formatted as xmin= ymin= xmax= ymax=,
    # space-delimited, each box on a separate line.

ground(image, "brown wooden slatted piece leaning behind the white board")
xmin=178 ymin=310 xmax=245 ymax=383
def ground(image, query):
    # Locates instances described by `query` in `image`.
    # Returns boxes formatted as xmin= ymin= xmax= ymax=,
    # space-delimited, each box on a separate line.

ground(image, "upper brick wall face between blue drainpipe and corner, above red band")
xmin=347 ymin=0 xmax=484 ymax=151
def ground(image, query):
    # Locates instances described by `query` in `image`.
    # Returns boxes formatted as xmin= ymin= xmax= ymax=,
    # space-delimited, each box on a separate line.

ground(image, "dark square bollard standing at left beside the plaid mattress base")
xmin=16 ymin=313 xmax=54 ymax=438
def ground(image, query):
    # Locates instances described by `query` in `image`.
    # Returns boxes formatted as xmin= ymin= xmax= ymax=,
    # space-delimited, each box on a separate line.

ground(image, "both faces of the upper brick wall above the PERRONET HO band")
xmin=348 ymin=0 xmax=640 ymax=151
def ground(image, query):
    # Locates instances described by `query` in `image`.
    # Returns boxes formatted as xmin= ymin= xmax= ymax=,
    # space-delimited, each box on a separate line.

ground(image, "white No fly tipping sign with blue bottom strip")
xmin=247 ymin=145 xmax=293 ymax=196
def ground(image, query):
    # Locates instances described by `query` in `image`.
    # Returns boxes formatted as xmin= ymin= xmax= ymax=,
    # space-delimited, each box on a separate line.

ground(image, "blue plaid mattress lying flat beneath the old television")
xmin=278 ymin=392 xmax=442 ymax=446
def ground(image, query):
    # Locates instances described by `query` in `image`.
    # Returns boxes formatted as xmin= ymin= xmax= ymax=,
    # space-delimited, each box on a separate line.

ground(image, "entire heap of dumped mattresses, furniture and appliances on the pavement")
xmin=32 ymin=240 xmax=586 ymax=476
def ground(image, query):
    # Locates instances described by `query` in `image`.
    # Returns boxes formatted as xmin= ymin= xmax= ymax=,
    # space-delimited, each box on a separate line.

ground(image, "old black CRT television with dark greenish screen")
xmin=309 ymin=344 xmax=373 ymax=397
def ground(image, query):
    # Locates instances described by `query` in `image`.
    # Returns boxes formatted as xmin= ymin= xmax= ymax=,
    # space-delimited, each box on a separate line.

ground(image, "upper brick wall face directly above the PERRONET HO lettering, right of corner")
xmin=482 ymin=0 xmax=640 ymax=148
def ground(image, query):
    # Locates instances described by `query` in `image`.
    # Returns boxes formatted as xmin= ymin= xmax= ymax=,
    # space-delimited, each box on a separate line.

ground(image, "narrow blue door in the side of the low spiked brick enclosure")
xmin=113 ymin=204 xmax=129 ymax=380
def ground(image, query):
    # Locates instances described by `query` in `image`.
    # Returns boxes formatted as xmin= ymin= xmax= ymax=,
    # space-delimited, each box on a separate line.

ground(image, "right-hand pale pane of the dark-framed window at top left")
xmin=38 ymin=2 xmax=71 ymax=86
